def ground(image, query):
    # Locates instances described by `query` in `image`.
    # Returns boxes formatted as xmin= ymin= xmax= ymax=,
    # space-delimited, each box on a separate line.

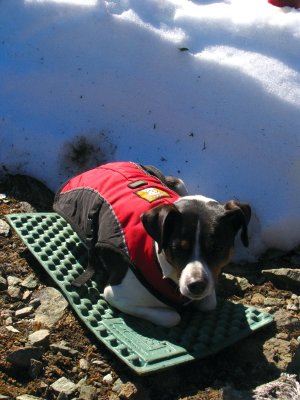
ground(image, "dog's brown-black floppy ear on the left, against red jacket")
xmin=141 ymin=204 xmax=181 ymax=253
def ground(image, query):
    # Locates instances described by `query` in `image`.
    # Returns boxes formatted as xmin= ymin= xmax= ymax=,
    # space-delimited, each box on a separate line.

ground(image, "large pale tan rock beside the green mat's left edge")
xmin=35 ymin=287 xmax=68 ymax=327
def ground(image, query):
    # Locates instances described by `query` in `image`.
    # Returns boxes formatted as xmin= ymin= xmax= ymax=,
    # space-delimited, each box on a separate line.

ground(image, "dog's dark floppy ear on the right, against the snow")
xmin=225 ymin=200 xmax=251 ymax=247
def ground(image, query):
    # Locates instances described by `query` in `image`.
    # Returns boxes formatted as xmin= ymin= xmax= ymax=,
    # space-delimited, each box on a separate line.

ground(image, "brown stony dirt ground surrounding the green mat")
xmin=0 ymin=176 xmax=300 ymax=400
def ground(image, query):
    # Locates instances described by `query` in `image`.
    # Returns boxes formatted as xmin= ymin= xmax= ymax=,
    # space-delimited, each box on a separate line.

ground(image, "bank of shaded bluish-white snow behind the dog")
xmin=0 ymin=0 xmax=300 ymax=259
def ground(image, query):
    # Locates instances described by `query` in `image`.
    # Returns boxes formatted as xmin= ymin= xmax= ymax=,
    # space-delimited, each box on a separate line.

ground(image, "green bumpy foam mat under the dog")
xmin=7 ymin=213 xmax=273 ymax=375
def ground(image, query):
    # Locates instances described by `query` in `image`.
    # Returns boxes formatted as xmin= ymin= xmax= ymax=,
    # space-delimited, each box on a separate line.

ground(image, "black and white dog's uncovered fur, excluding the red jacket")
xmin=56 ymin=162 xmax=251 ymax=327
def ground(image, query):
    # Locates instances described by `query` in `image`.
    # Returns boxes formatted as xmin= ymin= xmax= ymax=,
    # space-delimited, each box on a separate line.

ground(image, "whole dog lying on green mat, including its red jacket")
xmin=54 ymin=162 xmax=251 ymax=327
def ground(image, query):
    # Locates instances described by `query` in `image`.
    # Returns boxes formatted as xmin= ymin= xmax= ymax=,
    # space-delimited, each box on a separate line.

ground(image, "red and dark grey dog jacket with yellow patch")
xmin=54 ymin=162 xmax=187 ymax=306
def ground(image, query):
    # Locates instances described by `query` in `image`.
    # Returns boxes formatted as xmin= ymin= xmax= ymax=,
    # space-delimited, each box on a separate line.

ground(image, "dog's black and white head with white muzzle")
xmin=141 ymin=196 xmax=251 ymax=300
